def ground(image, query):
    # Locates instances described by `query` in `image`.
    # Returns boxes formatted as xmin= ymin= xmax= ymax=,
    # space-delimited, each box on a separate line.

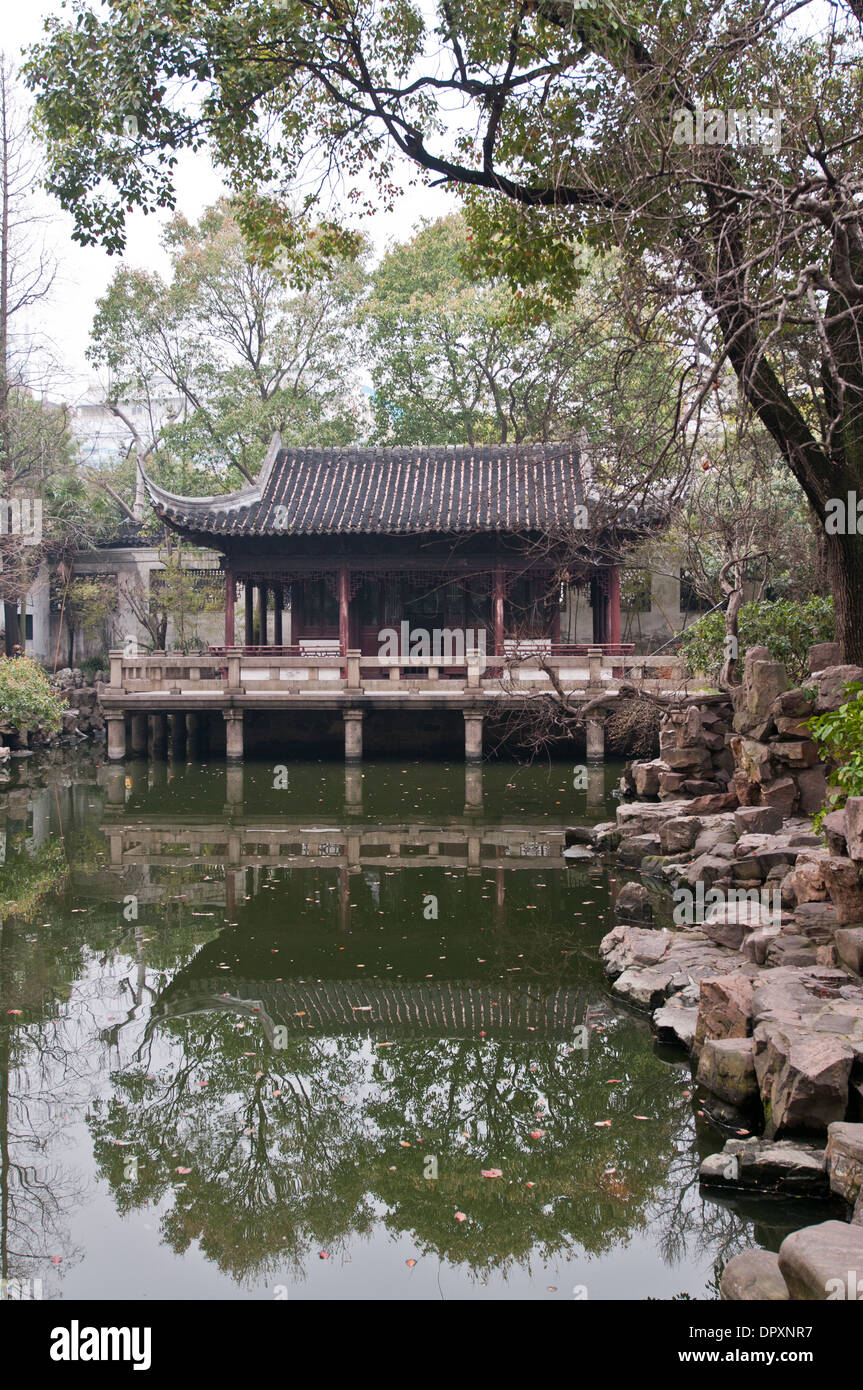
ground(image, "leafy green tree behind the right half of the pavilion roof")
xmin=361 ymin=214 xmax=678 ymax=450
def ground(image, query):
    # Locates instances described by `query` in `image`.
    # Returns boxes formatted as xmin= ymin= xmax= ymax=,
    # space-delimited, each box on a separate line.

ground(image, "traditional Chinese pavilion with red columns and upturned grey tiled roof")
xmin=145 ymin=435 xmax=661 ymax=655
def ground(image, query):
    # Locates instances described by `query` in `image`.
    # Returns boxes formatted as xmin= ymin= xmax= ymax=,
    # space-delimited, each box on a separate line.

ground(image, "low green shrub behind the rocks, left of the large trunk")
xmin=681 ymin=596 xmax=834 ymax=684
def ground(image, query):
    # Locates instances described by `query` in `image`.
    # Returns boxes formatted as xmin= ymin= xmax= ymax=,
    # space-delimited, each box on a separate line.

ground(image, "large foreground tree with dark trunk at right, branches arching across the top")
xmin=23 ymin=0 xmax=863 ymax=662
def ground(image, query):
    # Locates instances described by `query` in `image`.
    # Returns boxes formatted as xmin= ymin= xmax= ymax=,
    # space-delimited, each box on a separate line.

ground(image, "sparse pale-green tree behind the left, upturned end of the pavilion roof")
xmin=89 ymin=202 xmax=363 ymax=521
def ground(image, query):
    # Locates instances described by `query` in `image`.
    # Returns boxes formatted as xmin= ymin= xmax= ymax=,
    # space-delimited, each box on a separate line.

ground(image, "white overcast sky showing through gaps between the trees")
xmin=8 ymin=0 xmax=456 ymax=403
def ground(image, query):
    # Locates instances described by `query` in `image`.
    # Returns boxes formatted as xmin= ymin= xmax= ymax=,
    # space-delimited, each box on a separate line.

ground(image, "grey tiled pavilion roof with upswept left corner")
xmin=145 ymin=435 xmax=600 ymax=537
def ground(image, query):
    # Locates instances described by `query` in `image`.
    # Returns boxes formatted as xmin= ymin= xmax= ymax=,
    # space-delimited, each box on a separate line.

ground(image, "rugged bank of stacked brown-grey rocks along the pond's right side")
xmin=591 ymin=648 xmax=863 ymax=1301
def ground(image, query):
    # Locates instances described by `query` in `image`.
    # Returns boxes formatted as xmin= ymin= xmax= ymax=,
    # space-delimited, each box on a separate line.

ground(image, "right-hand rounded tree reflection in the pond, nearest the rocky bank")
xmin=371 ymin=1020 xmax=687 ymax=1270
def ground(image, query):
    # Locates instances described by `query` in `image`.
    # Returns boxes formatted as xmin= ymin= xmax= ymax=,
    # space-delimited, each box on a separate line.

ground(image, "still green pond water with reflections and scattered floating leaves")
xmin=0 ymin=759 xmax=817 ymax=1300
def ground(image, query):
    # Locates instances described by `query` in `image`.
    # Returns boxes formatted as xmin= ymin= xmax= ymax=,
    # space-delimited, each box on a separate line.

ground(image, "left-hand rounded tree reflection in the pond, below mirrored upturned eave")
xmin=90 ymin=1015 xmax=372 ymax=1279
